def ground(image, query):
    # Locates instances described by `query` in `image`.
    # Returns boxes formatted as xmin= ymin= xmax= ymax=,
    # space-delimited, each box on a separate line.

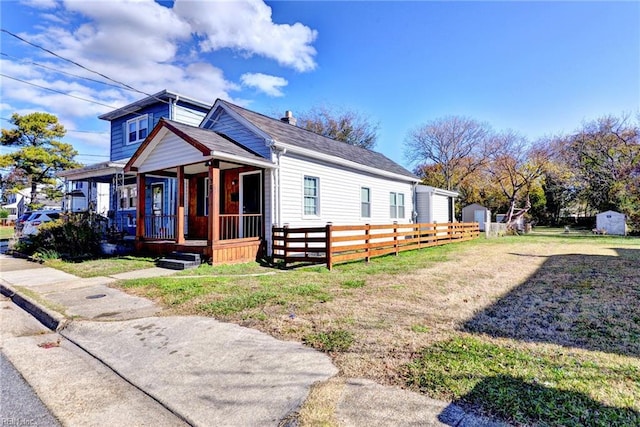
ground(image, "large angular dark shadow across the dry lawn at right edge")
xmin=463 ymin=248 xmax=640 ymax=357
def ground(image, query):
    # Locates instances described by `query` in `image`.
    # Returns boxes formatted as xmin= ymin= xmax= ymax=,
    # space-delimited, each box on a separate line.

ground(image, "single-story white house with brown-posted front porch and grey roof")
xmin=125 ymin=100 xmax=422 ymax=262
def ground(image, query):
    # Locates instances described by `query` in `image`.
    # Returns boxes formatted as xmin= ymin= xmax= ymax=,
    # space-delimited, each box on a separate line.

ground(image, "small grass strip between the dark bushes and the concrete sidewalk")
xmin=45 ymin=256 xmax=155 ymax=277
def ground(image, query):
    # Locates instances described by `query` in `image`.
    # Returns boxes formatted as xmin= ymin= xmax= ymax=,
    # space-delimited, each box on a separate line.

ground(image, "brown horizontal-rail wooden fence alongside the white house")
xmin=272 ymin=222 xmax=480 ymax=270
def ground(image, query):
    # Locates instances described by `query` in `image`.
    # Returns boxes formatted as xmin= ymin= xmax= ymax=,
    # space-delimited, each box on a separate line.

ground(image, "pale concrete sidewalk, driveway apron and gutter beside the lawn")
xmin=0 ymin=255 xmax=510 ymax=427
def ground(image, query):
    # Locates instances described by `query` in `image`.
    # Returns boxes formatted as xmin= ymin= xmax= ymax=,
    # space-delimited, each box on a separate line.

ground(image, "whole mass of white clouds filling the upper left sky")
xmin=0 ymin=0 xmax=316 ymax=134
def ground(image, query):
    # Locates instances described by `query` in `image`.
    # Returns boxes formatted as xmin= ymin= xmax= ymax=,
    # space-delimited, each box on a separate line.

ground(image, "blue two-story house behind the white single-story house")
xmin=59 ymin=90 xmax=211 ymax=237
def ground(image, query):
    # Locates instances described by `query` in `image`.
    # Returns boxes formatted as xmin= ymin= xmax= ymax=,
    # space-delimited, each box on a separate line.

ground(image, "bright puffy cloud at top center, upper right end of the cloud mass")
xmin=173 ymin=0 xmax=317 ymax=71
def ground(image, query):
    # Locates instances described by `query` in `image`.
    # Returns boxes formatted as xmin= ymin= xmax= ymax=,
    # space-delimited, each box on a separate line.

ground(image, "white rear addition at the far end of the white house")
xmin=415 ymin=185 xmax=458 ymax=224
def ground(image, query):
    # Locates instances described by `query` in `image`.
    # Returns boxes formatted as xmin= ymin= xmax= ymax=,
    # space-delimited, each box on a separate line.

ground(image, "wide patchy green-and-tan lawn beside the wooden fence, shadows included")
xmin=115 ymin=234 xmax=640 ymax=425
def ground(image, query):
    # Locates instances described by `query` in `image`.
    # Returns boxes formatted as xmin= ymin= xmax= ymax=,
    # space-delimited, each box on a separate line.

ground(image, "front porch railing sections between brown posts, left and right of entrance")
xmin=144 ymin=214 xmax=262 ymax=240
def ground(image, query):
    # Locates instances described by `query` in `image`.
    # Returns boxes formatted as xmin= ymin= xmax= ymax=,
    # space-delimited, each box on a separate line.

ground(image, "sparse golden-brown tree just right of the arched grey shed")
xmin=487 ymin=131 xmax=549 ymax=229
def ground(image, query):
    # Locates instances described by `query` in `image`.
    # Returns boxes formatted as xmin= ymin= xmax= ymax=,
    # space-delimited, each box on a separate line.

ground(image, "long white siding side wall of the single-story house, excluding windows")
xmin=280 ymin=153 xmax=413 ymax=227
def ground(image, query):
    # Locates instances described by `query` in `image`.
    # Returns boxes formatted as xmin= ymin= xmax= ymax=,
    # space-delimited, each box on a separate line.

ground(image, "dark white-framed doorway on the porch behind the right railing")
xmin=239 ymin=171 xmax=262 ymax=237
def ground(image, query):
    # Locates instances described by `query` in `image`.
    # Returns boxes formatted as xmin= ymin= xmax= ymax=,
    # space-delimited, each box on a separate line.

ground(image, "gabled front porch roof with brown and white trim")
xmin=125 ymin=118 xmax=276 ymax=171
